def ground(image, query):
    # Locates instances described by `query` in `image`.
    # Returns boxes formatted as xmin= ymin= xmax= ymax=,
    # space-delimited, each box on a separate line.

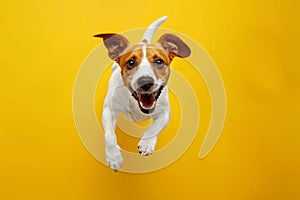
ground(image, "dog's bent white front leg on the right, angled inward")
xmin=138 ymin=111 xmax=170 ymax=156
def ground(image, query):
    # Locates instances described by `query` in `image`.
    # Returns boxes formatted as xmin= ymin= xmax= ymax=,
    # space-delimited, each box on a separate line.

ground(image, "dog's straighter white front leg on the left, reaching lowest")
xmin=102 ymin=106 xmax=123 ymax=171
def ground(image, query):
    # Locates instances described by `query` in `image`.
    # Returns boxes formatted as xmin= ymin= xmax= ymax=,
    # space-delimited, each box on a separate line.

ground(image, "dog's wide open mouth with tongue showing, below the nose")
xmin=132 ymin=86 xmax=163 ymax=114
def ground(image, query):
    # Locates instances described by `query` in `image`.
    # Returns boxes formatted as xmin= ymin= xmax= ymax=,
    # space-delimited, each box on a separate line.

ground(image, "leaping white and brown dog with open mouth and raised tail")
xmin=94 ymin=16 xmax=191 ymax=171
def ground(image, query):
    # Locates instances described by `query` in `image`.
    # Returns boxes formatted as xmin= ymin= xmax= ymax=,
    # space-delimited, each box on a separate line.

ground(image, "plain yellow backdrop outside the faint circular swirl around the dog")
xmin=0 ymin=0 xmax=300 ymax=200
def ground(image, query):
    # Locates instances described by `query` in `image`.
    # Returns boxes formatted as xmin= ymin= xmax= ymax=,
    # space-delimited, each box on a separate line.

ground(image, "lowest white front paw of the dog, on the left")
xmin=106 ymin=145 xmax=123 ymax=171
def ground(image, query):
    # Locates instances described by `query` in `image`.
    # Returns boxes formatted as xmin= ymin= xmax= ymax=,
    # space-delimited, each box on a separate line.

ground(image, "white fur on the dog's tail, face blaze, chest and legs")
xmin=102 ymin=17 xmax=170 ymax=170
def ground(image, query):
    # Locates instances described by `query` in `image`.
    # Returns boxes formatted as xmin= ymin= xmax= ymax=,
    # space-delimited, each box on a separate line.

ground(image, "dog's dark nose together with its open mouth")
xmin=132 ymin=77 xmax=164 ymax=114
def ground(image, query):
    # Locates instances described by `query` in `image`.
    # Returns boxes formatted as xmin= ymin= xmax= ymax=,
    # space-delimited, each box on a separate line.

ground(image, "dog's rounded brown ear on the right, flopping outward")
xmin=158 ymin=33 xmax=191 ymax=59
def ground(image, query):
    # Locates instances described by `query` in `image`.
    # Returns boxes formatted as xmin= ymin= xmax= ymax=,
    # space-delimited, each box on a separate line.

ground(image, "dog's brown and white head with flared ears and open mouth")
xmin=95 ymin=34 xmax=191 ymax=114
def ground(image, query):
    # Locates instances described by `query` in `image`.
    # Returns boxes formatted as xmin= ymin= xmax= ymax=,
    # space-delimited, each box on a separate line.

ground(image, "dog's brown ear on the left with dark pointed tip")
xmin=94 ymin=33 xmax=129 ymax=60
